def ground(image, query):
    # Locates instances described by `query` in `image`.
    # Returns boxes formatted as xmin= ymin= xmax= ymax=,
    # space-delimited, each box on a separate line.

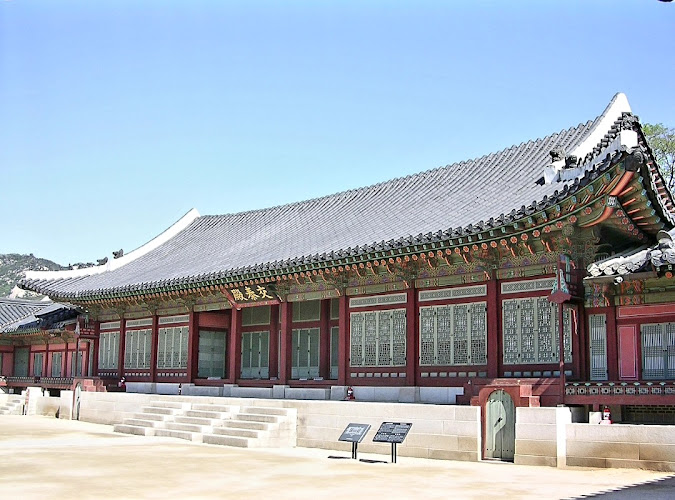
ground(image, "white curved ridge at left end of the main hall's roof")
xmin=26 ymin=208 xmax=199 ymax=280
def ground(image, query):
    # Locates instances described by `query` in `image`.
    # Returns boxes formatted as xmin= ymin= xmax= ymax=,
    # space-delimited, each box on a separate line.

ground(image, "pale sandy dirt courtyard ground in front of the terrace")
xmin=0 ymin=415 xmax=675 ymax=500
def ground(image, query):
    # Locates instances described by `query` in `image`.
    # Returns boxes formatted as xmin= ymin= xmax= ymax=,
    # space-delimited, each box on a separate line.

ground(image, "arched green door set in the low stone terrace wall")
xmin=485 ymin=390 xmax=516 ymax=461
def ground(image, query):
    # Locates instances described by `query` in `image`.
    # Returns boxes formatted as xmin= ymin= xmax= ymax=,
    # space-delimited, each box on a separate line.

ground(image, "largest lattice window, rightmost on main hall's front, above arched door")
xmin=502 ymin=297 xmax=572 ymax=364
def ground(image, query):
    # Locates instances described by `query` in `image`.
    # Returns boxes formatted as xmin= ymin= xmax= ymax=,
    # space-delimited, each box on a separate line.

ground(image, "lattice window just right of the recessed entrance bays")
xmin=350 ymin=309 xmax=406 ymax=366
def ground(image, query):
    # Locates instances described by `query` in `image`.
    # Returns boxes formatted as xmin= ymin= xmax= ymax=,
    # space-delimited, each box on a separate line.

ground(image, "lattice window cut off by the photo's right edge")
xmin=641 ymin=323 xmax=675 ymax=380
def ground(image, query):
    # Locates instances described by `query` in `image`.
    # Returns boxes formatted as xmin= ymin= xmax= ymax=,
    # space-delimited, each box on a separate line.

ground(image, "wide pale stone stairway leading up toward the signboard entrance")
xmin=114 ymin=397 xmax=297 ymax=448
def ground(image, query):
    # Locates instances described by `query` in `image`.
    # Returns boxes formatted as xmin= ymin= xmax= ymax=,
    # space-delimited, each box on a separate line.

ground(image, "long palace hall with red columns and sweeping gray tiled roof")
xmin=6 ymin=94 xmax=675 ymax=423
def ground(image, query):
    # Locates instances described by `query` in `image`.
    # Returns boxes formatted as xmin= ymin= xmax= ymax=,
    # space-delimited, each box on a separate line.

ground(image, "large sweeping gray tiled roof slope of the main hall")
xmin=22 ymin=94 xmax=672 ymax=298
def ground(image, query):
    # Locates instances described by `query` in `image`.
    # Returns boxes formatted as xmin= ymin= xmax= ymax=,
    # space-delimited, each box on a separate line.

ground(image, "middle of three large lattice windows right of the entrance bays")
xmin=419 ymin=302 xmax=487 ymax=366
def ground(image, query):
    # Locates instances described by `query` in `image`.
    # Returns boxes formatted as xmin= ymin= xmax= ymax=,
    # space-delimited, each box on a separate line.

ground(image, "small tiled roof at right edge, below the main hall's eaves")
xmin=588 ymin=228 xmax=675 ymax=278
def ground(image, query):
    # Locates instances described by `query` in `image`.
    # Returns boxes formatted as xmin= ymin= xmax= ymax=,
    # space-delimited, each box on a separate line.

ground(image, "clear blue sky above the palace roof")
xmin=0 ymin=0 xmax=675 ymax=265
